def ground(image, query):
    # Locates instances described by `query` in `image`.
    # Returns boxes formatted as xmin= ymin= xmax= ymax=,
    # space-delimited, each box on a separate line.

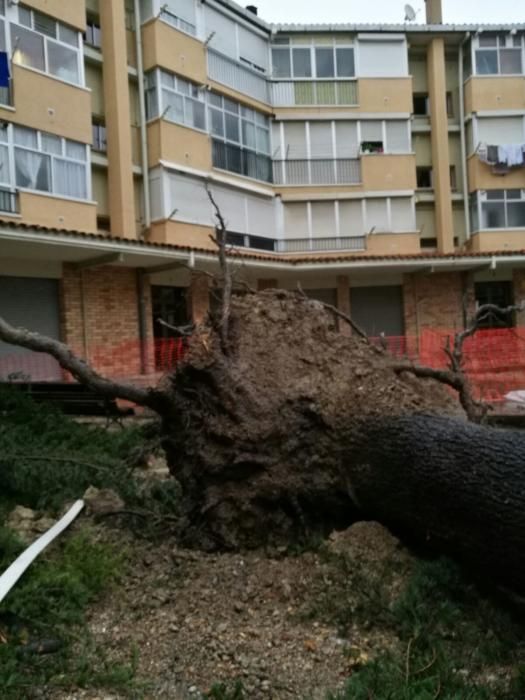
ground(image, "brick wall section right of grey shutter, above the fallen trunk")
xmin=403 ymin=272 xmax=474 ymax=336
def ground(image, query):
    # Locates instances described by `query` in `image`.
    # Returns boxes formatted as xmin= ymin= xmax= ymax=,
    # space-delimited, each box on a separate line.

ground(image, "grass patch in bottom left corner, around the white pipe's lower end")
xmin=0 ymin=527 xmax=141 ymax=700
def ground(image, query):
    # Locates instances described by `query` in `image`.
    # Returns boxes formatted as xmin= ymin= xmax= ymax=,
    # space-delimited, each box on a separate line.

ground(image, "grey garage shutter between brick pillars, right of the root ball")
xmin=350 ymin=286 xmax=405 ymax=337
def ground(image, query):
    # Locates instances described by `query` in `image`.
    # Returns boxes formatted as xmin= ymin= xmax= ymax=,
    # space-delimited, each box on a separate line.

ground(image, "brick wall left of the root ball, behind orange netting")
xmin=61 ymin=265 xmax=154 ymax=377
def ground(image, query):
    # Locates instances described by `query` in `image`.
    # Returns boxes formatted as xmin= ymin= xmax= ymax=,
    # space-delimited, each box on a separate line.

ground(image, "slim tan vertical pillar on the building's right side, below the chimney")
xmin=427 ymin=38 xmax=454 ymax=253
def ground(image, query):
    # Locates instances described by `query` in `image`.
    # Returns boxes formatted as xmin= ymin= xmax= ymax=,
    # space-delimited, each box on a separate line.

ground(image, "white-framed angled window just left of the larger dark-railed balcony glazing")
xmin=145 ymin=70 xmax=206 ymax=131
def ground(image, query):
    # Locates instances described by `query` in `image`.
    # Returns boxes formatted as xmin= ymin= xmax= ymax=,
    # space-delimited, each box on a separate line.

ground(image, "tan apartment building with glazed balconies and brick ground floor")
xmin=0 ymin=0 xmax=525 ymax=378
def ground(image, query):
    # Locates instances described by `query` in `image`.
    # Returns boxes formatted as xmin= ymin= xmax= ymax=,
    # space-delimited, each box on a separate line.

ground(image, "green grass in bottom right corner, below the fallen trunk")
xmin=316 ymin=557 xmax=525 ymax=700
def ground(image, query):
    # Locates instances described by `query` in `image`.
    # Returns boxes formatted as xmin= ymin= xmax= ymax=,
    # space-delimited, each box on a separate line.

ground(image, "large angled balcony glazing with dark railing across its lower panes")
xmin=208 ymin=93 xmax=272 ymax=182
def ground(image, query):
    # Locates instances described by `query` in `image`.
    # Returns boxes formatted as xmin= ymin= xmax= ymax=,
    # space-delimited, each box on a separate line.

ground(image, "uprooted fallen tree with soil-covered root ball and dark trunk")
xmin=5 ymin=290 xmax=525 ymax=590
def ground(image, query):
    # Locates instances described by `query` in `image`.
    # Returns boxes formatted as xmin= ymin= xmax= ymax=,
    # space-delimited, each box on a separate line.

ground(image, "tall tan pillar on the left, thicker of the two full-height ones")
xmin=100 ymin=0 xmax=137 ymax=238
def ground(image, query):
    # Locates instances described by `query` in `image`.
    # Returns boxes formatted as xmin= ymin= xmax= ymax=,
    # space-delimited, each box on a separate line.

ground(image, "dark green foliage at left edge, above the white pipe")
xmin=0 ymin=388 xmax=180 ymax=534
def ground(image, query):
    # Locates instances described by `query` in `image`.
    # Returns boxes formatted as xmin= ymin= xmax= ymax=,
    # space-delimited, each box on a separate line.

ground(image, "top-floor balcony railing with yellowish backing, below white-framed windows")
xmin=271 ymin=80 xmax=359 ymax=107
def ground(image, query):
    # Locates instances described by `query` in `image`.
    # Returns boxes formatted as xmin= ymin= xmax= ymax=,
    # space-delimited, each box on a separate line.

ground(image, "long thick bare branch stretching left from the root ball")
xmin=0 ymin=317 xmax=167 ymax=413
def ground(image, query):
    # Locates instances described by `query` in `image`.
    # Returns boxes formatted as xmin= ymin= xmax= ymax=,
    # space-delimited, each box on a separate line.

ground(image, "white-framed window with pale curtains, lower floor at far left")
xmin=13 ymin=125 xmax=88 ymax=199
